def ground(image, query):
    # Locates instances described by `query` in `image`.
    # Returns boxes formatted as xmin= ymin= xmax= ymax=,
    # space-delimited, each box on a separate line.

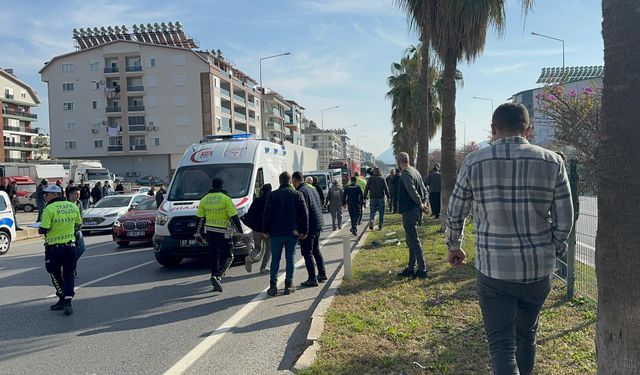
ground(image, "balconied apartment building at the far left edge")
xmin=0 ymin=68 xmax=40 ymax=163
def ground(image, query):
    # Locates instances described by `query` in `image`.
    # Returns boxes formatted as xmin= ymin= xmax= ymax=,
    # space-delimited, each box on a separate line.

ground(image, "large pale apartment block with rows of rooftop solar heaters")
xmin=40 ymin=23 xmax=262 ymax=179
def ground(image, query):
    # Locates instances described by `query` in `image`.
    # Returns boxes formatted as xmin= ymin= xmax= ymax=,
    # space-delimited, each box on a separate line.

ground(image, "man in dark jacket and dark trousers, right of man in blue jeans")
xmin=291 ymin=172 xmax=327 ymax=287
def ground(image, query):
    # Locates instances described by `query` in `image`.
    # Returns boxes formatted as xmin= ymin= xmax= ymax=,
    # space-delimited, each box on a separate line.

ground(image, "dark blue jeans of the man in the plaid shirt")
xmin=477 ymin=272 xmax=551 ymax=375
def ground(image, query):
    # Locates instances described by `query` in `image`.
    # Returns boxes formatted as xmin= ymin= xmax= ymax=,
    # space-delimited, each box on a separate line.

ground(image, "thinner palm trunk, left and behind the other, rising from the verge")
xmin=416 ymin=30 xmax=430 ymax=178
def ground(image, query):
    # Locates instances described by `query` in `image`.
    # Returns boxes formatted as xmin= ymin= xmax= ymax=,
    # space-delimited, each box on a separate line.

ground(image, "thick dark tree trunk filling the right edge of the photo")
xmin=596 ymin=0 xmax=640 ymax=374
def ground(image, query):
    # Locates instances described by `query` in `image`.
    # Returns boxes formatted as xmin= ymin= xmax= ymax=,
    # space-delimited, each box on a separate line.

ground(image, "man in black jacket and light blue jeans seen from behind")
xmin=262 ymin=172 xmax=309 ymax=296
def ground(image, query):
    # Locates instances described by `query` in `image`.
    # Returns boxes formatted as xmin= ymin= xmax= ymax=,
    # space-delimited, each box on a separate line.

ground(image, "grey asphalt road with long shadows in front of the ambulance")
xmin=0 ymin=210 xmax=372 ymax=374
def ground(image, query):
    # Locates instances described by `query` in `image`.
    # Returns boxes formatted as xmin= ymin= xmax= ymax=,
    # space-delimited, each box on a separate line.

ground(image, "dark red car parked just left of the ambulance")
xmin=112 ymin=197 xmax=157 ymax=247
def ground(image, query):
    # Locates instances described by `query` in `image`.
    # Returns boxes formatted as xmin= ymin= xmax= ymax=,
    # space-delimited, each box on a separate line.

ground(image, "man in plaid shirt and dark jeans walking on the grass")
xmin=446 ymin=103 xmax=573 ymax=375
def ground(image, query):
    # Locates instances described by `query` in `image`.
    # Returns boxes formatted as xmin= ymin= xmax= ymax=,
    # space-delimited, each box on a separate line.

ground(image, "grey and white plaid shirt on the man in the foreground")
xmin=446 ymin=137 xmax=573 ymax=282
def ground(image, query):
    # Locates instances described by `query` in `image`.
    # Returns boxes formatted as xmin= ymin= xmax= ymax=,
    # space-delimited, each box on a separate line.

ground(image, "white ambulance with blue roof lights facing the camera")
xmin=153 ymin=134 xmax=291 ymax=266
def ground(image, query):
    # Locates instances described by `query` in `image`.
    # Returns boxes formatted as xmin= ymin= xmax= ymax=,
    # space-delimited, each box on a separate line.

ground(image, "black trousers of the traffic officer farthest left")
xmin=44 ymin=245 xmax=76 ymax=298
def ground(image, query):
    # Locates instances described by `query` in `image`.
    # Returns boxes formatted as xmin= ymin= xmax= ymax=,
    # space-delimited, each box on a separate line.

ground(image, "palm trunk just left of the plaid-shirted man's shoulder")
xmin=440 ymin=52 xmax=457 ymax=225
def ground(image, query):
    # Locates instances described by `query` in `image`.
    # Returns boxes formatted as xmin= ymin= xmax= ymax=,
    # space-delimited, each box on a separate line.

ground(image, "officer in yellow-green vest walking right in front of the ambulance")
xmin=196 ymin=178 xmax=242 ymax=292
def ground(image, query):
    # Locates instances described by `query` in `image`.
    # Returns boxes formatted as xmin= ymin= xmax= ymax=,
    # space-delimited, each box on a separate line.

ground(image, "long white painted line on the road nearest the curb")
xmin=164 ymin=225 xmax=352 ymax=375
